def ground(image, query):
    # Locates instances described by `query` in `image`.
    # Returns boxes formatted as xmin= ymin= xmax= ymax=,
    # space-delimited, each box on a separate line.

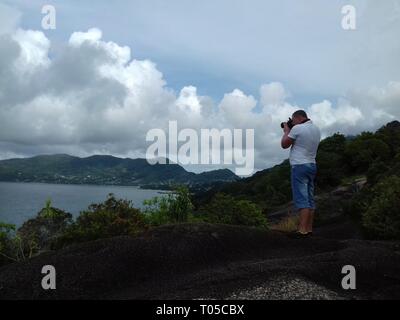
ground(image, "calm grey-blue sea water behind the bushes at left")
xmin=0 ymin=182 xmax=164 ymax=227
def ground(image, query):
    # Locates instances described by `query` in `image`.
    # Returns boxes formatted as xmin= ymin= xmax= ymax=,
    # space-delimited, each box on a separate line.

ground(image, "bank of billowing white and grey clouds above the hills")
xmin=0 ymin=8 xmax=400 ymax=174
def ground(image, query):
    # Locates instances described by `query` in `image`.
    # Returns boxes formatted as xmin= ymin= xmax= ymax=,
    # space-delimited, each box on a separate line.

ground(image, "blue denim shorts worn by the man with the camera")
xmin=291 ymin=163 xmax=317 ymax=209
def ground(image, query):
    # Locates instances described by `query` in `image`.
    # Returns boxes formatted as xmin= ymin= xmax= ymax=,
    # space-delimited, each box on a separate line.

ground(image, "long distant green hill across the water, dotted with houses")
xmin=0 ymin=154 xmax=239 ymax=188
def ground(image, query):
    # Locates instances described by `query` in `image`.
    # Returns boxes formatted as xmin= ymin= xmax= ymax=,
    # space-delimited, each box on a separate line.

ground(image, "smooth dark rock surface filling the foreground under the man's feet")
xmin=0 ymin=223 xmax=400 ymax=299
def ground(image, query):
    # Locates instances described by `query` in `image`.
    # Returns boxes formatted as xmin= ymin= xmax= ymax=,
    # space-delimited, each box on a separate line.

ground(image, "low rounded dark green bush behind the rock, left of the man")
xmin=201 ymin=193 xmax=267 ymax=227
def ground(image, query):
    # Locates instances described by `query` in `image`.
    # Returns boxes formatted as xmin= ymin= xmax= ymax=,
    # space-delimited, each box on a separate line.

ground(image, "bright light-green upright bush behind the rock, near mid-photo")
xmin=143 ymin=187 xmax=193 ymax=226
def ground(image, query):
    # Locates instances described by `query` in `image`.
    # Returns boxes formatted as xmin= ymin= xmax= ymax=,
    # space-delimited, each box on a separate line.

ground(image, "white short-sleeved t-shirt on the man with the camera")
xmin=288 ymin=120 xmax=321 ymax=165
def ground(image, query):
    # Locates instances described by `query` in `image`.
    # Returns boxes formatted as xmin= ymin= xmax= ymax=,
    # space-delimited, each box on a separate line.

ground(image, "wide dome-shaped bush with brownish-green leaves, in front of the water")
xmin=54 ymin=193 xmax=147 ymax=248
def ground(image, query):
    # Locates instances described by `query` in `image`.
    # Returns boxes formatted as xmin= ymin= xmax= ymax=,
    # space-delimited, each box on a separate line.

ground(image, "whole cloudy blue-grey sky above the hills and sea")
xmin=0 ymin=0 xmax=400 ymax=172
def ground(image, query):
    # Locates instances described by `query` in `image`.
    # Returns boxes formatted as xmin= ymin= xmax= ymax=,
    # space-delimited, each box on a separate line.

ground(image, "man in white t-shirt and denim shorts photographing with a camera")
xmin=281 ymin=110 xmax=321 ymax=237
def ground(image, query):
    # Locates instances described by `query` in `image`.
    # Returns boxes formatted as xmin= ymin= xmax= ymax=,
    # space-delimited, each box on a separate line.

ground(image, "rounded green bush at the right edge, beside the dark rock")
xmin=362 ymin=176 xmax=400 ymax=240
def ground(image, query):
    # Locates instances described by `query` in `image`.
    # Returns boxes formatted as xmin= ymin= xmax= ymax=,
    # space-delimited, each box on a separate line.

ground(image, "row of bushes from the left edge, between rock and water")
xmin=0 ymin=194 xmax=146 ymax=266
